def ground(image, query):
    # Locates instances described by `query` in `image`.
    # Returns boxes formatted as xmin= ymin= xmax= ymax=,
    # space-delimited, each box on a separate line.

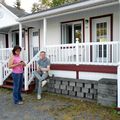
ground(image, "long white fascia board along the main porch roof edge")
xmin=18 ymin=0 xmax=118 ymax=22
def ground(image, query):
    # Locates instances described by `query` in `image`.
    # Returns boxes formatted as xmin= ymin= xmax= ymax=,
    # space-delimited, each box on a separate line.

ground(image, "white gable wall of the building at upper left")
xmin=0 ymin=6 xmax=18 ymax=28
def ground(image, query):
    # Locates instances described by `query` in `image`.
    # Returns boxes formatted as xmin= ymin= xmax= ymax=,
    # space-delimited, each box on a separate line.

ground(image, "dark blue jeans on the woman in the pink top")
xmin=12 ymin=73 xmax=23 ymax=104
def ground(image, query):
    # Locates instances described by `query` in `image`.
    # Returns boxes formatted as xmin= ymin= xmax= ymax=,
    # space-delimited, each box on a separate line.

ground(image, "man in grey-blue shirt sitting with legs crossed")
xmin=33 ymin=51 xmax=50 ymax=99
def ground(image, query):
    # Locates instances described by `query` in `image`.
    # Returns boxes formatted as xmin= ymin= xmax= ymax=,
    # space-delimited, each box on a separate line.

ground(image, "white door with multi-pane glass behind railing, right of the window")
xmin=92 ymin=17 xmax=111 ymax=62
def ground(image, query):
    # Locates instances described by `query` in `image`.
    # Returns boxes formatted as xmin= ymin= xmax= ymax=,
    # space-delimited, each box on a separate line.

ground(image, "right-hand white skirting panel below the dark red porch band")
xmin=79 ymin=71 xmax=117 ymax=81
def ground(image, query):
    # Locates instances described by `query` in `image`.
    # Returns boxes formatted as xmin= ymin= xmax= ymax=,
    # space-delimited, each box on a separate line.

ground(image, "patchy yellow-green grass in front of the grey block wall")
xmin=0 ymin=88 xmax=120 ymax=120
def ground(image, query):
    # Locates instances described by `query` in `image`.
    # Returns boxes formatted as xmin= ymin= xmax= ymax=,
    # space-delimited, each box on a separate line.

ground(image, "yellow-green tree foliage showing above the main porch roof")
xmin=32 ymin=0 xmax=79 ymax=12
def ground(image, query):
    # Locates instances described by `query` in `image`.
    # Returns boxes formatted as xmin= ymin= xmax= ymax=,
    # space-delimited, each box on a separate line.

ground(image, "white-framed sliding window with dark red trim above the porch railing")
xmin=61 ymin=21 xmax=83 ymax=44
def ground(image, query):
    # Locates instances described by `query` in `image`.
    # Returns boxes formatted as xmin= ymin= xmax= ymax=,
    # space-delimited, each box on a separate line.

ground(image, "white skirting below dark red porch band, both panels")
xmin=49 ymin=70 xmax=117 ymax=81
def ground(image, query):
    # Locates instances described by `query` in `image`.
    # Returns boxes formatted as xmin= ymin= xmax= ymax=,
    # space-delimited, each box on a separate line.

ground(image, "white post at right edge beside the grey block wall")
xmin=117 ymin=64 xmax=120 ymax=108
